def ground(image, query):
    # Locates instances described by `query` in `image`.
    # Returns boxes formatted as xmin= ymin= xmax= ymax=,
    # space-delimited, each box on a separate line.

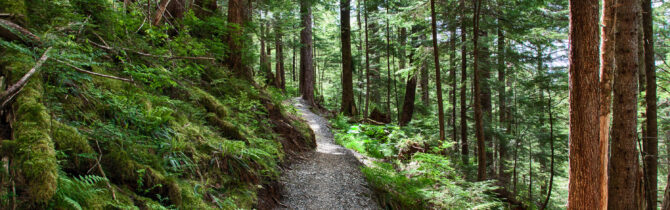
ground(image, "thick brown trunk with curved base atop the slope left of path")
xmin=225 ymin=0 xmax=253 ymax=81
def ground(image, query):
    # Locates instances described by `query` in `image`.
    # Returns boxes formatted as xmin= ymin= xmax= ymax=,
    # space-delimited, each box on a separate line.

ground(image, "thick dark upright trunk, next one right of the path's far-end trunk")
xmin=340 ymin=0 xmax=356 ymax=116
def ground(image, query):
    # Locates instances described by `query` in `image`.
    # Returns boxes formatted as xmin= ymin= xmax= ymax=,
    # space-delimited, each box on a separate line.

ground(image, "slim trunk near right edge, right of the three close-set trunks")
xmin=642 ymin=0 xmax=658 ymax=209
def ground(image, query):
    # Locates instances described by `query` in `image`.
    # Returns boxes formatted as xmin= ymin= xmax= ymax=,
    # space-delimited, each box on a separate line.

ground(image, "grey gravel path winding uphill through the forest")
xmin=281 ymin=99 xmax=380 ymax=209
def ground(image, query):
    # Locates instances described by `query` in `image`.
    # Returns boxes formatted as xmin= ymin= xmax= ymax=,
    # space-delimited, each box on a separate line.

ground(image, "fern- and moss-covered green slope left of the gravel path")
xmin=0 ymin=0 xmax=314 ymax=209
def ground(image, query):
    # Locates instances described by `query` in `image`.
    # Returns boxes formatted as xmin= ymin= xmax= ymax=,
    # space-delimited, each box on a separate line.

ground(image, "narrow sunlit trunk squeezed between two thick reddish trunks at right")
xmin=598 ymin=0 xmax=616 ymax=209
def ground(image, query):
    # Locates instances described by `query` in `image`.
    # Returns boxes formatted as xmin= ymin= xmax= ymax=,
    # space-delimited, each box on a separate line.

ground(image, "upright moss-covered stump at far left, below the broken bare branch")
xmin=7 ymin=55 xmax=58 ymax=204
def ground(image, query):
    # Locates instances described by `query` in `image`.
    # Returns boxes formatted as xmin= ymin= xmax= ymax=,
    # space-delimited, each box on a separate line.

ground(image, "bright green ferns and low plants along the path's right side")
xmin=331 ymin=115 xmax=503 ymax=209
